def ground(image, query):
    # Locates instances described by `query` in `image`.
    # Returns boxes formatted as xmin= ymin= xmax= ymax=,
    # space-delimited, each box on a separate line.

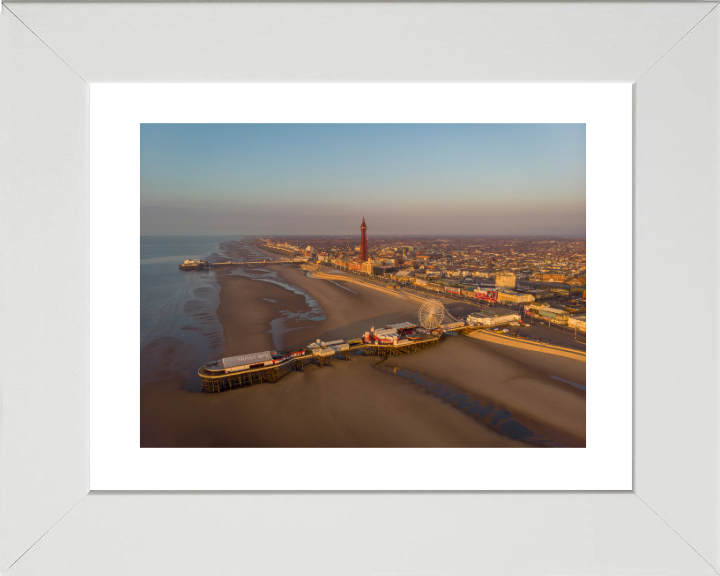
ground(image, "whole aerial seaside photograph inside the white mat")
xmin=139 ymin=123 xmax=587 ymax=448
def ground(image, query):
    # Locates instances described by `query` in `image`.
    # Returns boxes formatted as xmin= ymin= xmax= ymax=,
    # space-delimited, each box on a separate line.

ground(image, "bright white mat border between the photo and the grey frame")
xmin=90 ymin=82 xmax=632 ymax=491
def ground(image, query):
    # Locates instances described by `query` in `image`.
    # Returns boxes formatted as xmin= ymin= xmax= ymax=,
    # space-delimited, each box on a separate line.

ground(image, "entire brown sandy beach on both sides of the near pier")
xmin=141 ymin=243 xmax=585 ymax=447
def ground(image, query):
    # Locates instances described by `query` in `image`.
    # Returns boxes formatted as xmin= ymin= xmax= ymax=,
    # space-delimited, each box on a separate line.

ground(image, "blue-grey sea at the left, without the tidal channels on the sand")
xmin=140 ymin=236 xmax=241 ymax=388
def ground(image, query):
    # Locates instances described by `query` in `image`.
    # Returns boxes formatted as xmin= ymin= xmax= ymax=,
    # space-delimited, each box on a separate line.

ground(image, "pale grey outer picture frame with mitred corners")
xmin=0 ymin=2 xmax=720 ymax=575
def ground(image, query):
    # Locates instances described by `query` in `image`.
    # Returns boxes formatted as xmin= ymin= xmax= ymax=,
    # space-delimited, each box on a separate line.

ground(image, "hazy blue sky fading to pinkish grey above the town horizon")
xmin=140 ymin=124 xmax=585 ymax=236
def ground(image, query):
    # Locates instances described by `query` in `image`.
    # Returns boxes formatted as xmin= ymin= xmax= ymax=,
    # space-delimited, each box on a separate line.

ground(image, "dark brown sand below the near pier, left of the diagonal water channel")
xmin=141 ymin=356 xmax=525 ymax=447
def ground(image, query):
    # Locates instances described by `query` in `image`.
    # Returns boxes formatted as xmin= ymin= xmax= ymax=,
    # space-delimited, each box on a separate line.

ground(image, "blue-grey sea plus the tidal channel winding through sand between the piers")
xmin=140 ymin=236 xmax=325 ymax=390
